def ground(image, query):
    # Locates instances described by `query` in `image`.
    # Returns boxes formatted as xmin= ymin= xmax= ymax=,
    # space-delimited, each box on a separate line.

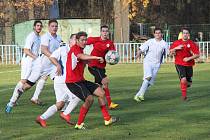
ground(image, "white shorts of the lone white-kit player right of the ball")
xmin=143 ymin=63 xmax=160 ymax=85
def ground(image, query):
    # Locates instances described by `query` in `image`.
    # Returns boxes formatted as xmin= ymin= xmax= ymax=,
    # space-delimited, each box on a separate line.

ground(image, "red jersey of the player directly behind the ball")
xmin=87 ymin=37 xmax=115 ymax=68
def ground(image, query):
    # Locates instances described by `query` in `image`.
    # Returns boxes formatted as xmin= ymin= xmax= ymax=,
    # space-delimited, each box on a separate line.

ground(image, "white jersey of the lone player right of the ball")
xmin=140 ymin=38 xmax=169 ymax=65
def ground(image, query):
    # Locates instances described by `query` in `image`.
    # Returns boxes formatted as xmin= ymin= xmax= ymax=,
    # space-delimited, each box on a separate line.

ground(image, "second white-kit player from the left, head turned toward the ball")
xmin=28 ymin=20 xmax=61 ymax=105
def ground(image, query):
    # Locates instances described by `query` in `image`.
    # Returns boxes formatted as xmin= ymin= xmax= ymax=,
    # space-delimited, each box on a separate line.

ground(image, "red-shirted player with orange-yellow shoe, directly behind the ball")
xmin=87 ymin=25 xmax=119 ymax=109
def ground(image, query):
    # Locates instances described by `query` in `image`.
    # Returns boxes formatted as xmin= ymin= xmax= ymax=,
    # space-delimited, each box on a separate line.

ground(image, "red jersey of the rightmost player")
xmin=170 ymin=39 xmax=199 ymax=66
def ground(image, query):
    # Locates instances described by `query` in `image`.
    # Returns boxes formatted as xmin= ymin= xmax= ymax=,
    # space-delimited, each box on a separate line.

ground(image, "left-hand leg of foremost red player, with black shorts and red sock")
xmin=66 ymin=82 xmax=93 ymax=129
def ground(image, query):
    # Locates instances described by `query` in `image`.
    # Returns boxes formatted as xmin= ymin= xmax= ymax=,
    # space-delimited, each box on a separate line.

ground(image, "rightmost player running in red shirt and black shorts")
xmin=170 ymin=28 xmax=200 ymax=101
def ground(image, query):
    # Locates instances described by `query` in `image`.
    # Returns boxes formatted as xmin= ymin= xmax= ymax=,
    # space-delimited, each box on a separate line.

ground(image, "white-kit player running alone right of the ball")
xmin=134 ymin=28 xmax=169 ymax=102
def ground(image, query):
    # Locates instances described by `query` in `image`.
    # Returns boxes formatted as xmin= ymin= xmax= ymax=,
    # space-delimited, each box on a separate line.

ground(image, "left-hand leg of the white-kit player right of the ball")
xmin=134 ymin=63 xmax=153 ymax=102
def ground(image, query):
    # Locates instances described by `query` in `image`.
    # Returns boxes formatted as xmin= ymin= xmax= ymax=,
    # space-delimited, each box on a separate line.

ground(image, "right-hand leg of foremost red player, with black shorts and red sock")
xmin=85 ymin=81 xmax=117 ymax=125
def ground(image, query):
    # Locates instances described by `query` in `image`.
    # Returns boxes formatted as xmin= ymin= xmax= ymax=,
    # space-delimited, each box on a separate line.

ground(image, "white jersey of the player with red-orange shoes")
xmin=50 ymin=45 xmax=70 ymax=83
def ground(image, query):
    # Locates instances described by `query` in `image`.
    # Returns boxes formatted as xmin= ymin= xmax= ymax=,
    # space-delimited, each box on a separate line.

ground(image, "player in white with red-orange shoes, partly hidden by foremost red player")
xmin=36 ymin=35 xmax=80 ymax=127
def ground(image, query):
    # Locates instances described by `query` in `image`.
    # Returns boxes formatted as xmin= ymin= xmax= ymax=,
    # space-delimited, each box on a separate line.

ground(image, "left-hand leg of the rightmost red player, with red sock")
xmin=175 ymin=65 xmax=187 ymax=101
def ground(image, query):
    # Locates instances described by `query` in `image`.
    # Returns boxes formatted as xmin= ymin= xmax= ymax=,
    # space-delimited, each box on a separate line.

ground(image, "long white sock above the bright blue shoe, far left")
xmin=9 ymin=81 xmax=23 ymax=106
